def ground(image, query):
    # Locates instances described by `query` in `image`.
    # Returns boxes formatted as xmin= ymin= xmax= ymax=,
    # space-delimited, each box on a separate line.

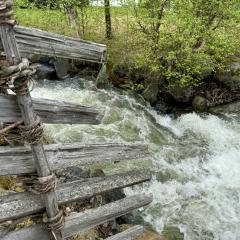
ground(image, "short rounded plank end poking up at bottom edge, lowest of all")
xmin=106 ymin=225 xmax=143 ymax=240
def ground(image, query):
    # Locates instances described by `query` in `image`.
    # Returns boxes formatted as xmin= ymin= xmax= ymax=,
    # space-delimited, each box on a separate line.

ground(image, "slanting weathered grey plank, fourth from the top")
xmin=0 ymin=170 xmax=151 ymax=222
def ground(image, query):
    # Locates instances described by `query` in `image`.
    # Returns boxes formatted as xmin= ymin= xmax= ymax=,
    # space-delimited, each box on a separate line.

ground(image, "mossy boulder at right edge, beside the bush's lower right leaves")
xmin=216 ymin=57 xmax=240 ymax=91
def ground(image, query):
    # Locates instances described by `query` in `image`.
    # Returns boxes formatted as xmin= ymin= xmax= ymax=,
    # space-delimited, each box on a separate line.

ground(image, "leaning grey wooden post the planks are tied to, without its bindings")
xmin=0 ymin=0 xmax=62 ymax=240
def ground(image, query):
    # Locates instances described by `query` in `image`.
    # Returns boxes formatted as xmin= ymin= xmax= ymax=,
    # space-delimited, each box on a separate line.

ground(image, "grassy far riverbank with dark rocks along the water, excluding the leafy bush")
xmin=16 ymin=6 xmax=240 ymax=115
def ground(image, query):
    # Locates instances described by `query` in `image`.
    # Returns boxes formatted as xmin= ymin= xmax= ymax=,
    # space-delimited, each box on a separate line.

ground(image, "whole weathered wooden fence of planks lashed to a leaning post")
xmin=0 ymin=0 xmax=152 ymax=240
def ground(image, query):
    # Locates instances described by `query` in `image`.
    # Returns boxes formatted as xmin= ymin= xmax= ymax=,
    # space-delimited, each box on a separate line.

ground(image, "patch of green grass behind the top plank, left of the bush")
xmin=15 ymin=7 xmax=139 ymax=67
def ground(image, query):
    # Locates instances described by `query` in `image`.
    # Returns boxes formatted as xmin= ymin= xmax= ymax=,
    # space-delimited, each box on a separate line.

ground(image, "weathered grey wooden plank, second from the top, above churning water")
xmin=0 ymin=95 xmax=104 ymax=124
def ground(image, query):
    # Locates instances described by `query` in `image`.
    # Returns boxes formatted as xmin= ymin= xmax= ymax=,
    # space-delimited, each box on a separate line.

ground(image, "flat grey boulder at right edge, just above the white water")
xmin=209 ymin=101 xmax=240 ymax=114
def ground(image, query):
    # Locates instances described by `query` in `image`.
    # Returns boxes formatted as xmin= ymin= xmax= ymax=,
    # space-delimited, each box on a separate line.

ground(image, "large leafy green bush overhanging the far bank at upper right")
xmin=132 ymin=0 xmax=240 ymax=86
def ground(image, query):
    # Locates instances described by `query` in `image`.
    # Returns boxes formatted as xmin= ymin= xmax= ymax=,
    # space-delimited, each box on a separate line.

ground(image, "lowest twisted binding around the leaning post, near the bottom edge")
xmin=43 ymin=210 xmax=64 ymax=240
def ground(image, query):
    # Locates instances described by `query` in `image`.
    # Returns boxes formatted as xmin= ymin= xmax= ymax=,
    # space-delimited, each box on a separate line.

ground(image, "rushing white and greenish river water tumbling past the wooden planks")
xmin=32 ymin=79 xmax=240 ymax=240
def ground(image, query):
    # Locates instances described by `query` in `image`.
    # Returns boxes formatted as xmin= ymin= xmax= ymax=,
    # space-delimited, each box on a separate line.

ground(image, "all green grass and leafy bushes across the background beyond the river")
xmin=16 ymin=0 xmax=240 ymax=88
